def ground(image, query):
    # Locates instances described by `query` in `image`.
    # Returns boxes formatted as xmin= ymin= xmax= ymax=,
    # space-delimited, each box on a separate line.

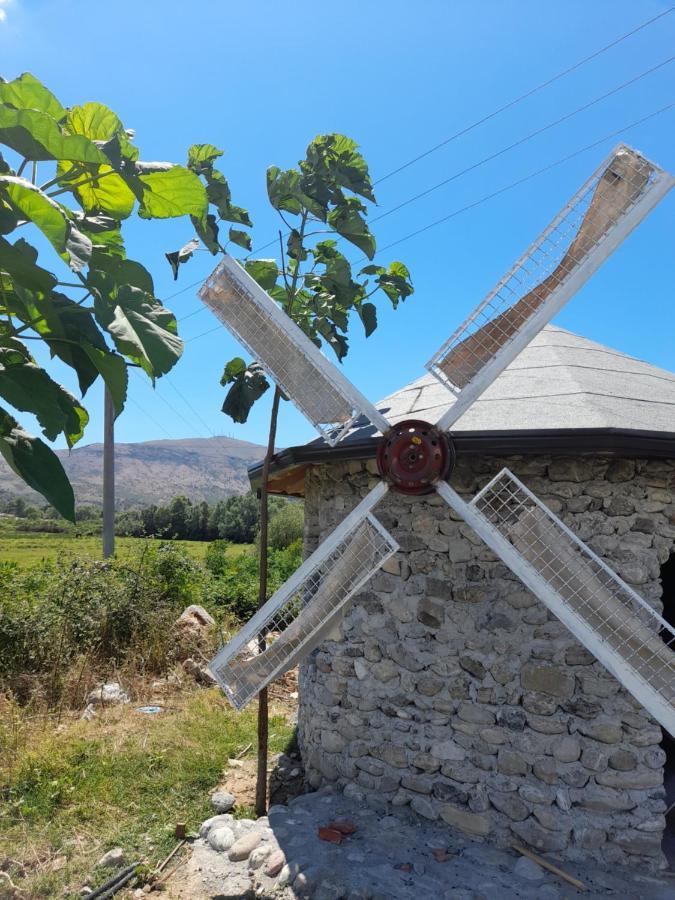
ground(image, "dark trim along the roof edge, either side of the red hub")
xmin=248 ymin=428 xmax=675 ymax=490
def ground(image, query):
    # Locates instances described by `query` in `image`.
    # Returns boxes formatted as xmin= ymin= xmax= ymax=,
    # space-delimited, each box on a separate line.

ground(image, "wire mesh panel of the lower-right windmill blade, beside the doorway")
xmin=471 ymin=470 xmax=675 ymax=707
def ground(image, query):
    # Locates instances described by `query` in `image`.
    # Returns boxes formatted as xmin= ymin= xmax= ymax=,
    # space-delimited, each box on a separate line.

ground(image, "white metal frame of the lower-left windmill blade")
xmin=209 ymin=481 xmax=399 ymax=709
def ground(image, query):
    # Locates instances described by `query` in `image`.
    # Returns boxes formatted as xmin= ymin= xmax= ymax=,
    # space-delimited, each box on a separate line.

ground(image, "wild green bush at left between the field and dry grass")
xmin=0 ymin=543 xmax=205 ymax=704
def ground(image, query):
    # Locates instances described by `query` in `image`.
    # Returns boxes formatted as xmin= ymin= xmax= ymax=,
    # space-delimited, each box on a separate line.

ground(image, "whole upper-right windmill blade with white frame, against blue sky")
xmin=426 ymin=145 xmax=675 ymax=430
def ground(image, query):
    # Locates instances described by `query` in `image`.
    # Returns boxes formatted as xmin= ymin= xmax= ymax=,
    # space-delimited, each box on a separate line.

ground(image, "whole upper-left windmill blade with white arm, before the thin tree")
xmin=199 ymin=255 xmax=389 ymax=447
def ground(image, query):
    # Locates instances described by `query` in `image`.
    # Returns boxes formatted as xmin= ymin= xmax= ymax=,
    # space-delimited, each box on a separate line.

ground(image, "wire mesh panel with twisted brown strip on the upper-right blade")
xmin=427 ymin=146 xmax=662 ymax=393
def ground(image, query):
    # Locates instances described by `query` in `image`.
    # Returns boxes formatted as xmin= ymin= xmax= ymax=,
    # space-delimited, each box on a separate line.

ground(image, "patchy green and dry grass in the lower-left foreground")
xmin=0 ymin=689 xmax=293 ymax=898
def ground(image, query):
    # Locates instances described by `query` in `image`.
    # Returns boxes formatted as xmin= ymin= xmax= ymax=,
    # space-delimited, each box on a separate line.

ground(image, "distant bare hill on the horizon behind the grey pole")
xmin=0 ymin=437 xmax=265 ymax=508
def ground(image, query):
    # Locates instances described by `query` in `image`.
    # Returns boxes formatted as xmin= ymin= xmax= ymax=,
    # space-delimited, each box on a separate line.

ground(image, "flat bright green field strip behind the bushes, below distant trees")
xmin=0 ymin=529 xmax=252 ymax=566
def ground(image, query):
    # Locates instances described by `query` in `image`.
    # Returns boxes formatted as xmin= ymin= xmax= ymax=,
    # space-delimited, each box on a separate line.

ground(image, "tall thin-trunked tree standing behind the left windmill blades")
xmin=202 ymin=134 xmax=413 ymax=815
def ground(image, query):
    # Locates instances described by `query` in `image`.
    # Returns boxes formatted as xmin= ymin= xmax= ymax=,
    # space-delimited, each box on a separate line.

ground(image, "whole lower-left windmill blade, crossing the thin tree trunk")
xmin=209 ymin=482 xmax=398 ymax=709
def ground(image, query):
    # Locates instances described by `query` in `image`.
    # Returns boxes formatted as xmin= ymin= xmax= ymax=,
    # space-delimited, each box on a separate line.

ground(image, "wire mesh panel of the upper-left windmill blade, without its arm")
xmin=199 ymin=260 xmax=360 ymax=443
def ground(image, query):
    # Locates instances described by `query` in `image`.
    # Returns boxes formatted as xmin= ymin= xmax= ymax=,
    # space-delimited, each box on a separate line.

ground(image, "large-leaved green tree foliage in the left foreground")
xmin=0 ymin=73 xmax=250 ymax=519
